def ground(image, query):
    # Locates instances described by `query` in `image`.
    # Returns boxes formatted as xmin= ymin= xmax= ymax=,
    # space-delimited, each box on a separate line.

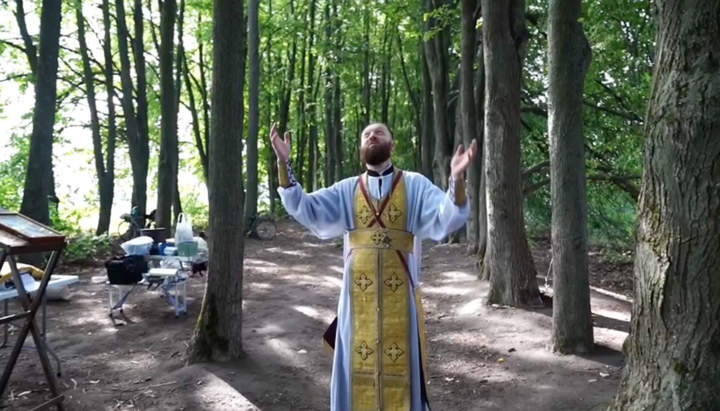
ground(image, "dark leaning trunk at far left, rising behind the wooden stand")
xmin=20 ymin=0 xmax=62 ymax=229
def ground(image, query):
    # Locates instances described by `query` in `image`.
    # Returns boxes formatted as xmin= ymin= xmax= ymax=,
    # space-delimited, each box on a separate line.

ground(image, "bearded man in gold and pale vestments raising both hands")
xmin=270 ymin=123 xmax=477 ymax=411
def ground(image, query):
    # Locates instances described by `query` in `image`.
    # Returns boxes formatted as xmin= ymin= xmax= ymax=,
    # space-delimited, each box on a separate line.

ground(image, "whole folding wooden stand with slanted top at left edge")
xmin=0 ymin=208 xmax=65 ymax=411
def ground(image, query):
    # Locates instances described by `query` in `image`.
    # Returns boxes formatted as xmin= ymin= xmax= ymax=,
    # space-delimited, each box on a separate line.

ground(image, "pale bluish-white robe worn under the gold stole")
xmin=278 ymin=170 xmax=470 ymax=411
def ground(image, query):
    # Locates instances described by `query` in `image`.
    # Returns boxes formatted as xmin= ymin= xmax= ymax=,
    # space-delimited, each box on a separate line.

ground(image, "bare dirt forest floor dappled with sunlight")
xmin=0 ymin=221 xmax=632 ymax=411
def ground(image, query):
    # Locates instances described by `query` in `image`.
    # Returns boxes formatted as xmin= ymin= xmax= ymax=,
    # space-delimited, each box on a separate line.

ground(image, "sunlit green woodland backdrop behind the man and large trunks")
xmin=0 ymin=0 xmax=654 ymax=266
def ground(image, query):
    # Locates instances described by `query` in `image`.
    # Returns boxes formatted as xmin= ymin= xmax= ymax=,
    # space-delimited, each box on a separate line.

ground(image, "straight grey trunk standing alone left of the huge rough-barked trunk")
xmin=548 ymin=0 xmax=593 ymax=354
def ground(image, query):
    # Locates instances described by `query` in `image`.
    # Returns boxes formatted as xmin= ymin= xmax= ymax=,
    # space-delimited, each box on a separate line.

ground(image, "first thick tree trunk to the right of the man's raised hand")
xmin=482 ymin=0 xmax=540 ymax=306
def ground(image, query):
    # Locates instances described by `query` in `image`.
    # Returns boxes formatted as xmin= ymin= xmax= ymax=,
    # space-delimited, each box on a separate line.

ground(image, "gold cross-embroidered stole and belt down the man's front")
xmin=349 ymin=170 xmax=427 ymax=411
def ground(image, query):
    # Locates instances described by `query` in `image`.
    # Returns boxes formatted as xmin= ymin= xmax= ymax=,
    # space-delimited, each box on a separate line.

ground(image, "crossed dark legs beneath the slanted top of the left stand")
xmin=0 ymin=244 xmax=65 ymax=411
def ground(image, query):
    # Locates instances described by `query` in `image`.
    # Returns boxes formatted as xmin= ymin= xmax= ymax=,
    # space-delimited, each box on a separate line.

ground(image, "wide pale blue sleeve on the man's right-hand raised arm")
xmin=413 ymin=176 xmax=470 ymax=241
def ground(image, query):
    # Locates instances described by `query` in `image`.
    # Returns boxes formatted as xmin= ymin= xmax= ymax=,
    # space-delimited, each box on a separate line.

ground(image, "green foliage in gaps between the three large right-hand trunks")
xmin=523 ymin=0 xmax=654 ymax=247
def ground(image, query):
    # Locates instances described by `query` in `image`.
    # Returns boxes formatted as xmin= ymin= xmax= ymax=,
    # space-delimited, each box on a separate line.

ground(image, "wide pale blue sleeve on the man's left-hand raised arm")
xmin=278 ymin=160 xmax=347 ymax=240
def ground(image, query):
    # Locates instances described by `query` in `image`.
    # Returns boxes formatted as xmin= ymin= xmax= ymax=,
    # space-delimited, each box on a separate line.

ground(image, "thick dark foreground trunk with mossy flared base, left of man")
xmin=188 ymin=0 xmax=246 ymax=363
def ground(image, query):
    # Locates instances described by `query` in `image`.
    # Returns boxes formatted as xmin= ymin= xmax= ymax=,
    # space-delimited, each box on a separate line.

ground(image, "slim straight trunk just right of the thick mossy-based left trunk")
xmin=245 ymin=0 xmax=260 ymax=222
